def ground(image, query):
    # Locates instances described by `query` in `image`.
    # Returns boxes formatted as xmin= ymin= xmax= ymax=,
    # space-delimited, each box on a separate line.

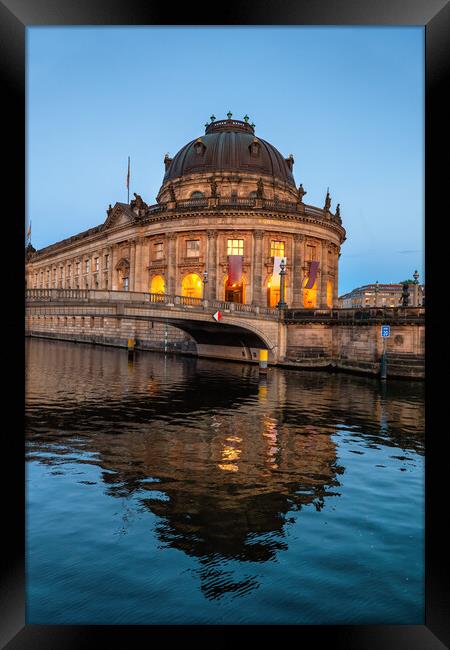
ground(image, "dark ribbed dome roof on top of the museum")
xmin=163 ymin=114 xmax=295 ymax=187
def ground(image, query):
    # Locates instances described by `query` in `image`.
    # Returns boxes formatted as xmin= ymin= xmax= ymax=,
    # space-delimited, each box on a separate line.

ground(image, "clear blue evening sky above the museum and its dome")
xmin=27 ymin=26 xmax=425 ymax=294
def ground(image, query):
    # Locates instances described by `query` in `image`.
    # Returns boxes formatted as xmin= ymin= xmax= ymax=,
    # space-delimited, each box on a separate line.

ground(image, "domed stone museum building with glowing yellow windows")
xmin=26 ymin=113 xmax=345 ymax=308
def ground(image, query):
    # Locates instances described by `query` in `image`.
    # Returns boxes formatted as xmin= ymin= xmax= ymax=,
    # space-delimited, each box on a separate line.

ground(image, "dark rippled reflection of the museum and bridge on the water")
xmin=26 ymin=340 xmax=423 ymax=599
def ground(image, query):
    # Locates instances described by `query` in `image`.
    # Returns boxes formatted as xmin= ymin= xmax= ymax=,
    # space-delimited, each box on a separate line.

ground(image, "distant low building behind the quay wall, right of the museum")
xmin=338 ymin=282 xmax=425 ymax=309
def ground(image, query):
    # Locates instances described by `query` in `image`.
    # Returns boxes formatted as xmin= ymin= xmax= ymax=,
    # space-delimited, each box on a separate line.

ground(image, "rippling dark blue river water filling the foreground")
xmin=26 ymin=339 xmax=424 ymax=625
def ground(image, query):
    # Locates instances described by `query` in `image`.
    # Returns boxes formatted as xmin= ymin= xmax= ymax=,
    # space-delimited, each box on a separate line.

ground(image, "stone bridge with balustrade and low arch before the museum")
xmin=26 ymin=289 xmax=286 ymax=363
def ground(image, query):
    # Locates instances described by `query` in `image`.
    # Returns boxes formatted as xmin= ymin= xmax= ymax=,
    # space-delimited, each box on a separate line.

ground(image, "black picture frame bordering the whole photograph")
xmin=0 ymin=0 xmax=450 ymax=650
